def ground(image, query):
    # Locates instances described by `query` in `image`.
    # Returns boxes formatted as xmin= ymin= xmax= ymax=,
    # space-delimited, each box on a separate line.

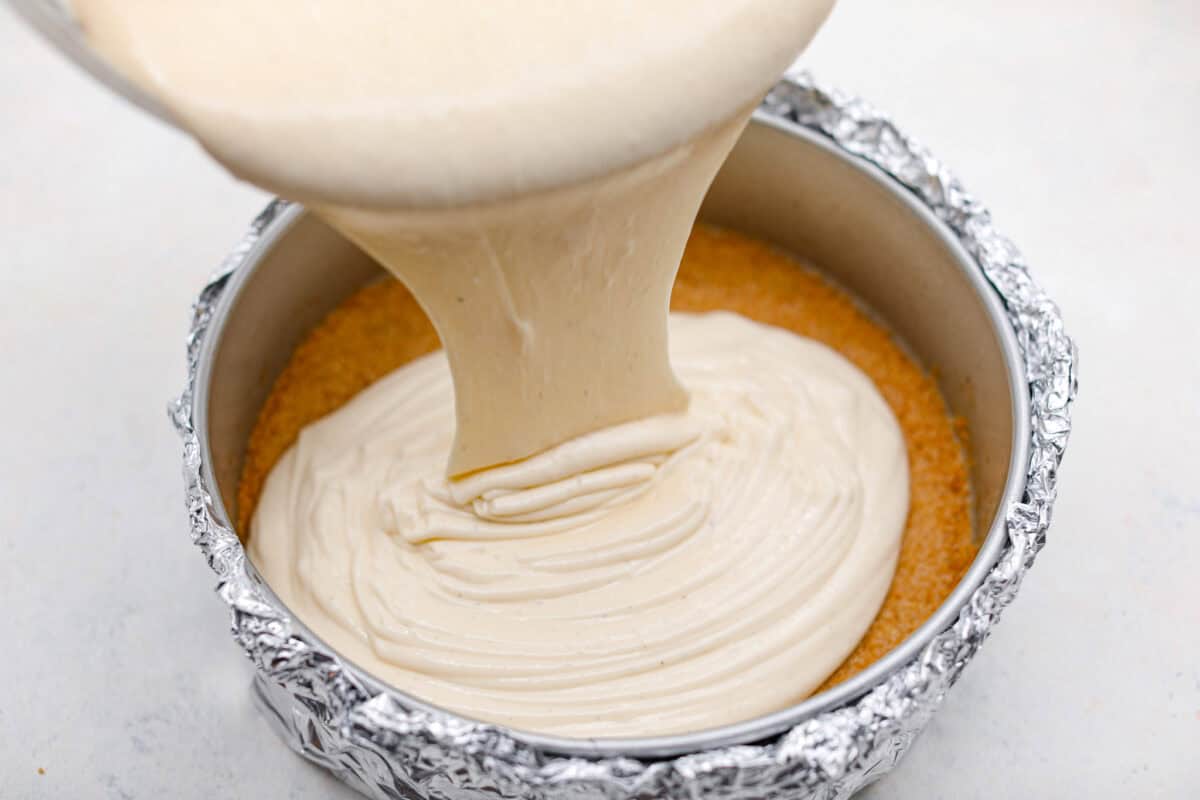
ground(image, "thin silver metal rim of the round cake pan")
xmin=193 ymin=110 xmax=1031 ymax=759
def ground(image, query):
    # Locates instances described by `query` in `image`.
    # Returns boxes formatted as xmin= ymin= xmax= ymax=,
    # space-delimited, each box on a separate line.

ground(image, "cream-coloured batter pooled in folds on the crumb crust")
xmin=250 ymin=312 xmax=908 ymax=736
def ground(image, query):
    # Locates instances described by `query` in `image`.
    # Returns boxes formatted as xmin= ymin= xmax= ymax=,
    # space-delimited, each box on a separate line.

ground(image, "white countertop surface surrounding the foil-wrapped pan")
xmin=0 ymin=0 xmax=1200 ymax=800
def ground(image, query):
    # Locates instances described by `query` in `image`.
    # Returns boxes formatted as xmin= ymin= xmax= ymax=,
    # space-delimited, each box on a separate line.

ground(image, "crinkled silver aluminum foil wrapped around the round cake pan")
xmin=172 ymin=74 xmax=1076 ymax=800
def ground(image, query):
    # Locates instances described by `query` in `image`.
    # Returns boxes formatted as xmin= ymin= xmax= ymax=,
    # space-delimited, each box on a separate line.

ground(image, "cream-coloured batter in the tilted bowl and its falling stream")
xmin=73 ymin=0 xmax=833 ymax=475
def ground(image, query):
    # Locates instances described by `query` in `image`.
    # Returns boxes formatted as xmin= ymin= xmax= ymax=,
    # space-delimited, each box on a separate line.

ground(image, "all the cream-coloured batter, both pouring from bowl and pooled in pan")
xmin=76 ymin=0 xmax=907 ymax=735
